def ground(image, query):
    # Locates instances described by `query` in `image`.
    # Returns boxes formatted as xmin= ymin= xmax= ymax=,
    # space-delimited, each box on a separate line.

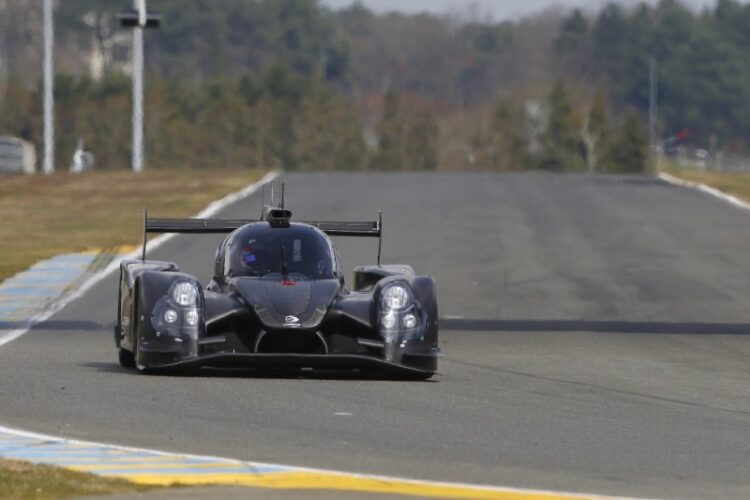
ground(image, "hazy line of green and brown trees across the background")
xmin=0 ymin=0 xmax=750 ymax=171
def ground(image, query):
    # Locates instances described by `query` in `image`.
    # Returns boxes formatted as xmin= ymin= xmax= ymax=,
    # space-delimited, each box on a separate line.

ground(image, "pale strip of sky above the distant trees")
xmin=321 ymin=0 xmax=728 ymax=21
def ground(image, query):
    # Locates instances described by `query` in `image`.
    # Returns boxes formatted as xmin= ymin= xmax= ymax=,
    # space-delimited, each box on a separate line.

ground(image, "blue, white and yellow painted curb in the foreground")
xmin=0 ymin=426 xmax=636 ymax=500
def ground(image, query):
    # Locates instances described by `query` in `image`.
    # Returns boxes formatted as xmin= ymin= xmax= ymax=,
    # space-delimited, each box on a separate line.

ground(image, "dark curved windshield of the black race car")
xmin=225 ymin=223 xmax=334 ymax=280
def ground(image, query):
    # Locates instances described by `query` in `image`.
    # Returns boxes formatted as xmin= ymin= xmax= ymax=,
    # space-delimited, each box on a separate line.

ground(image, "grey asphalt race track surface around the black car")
xmin=0 ymin=174 xmax=750 ymax=498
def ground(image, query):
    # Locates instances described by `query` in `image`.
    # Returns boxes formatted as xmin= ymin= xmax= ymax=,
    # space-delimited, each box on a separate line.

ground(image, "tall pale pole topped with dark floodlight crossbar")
xmin=119 ymin=0 xmax=161 ymax=173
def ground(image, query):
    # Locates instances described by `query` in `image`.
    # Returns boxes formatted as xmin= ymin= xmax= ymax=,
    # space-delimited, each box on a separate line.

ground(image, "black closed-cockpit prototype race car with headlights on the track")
xmin=115 ymin=203 xmax=440 ymax=379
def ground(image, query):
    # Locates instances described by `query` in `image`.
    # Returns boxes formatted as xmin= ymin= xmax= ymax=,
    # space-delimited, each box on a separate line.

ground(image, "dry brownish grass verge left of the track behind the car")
xmin=0 ymin=169 xmax=265 ymax=281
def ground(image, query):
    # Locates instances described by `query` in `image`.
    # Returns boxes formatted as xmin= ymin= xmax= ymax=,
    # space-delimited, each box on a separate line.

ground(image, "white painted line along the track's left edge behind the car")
xmin=0 ymin=170 xmax=281 ymax=346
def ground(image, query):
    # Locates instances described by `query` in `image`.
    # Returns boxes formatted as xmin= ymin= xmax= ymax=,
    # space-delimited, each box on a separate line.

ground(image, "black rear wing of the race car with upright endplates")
xmin=142 ymin=210 xmax=383 ymax=265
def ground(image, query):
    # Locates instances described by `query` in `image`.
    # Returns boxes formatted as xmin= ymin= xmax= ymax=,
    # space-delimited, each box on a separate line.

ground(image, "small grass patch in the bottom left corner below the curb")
xmin=0 ymin=459 xmax=162 ymax=500
